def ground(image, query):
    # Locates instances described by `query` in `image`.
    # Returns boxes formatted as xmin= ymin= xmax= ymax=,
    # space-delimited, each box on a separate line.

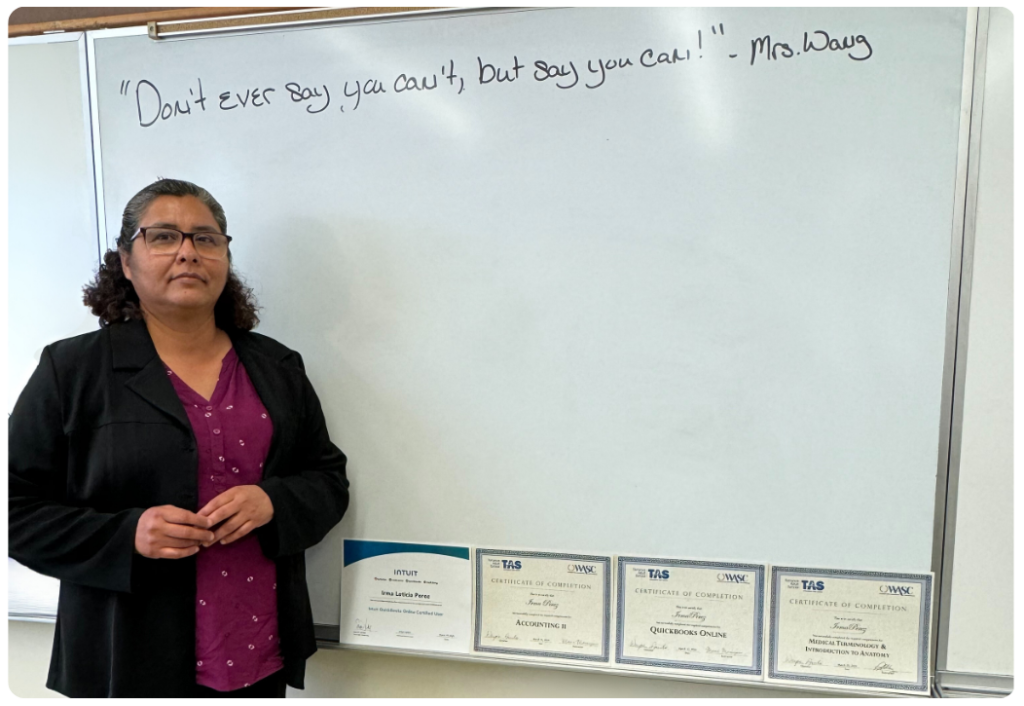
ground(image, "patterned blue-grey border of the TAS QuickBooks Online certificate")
xmin=615 ymin=556 xmax=767 ymax=676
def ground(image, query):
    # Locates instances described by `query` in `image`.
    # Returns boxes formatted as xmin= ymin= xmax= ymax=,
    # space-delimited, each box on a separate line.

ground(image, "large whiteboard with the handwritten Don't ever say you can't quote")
xmin=93 ymin=6 xmax=967 ymax=622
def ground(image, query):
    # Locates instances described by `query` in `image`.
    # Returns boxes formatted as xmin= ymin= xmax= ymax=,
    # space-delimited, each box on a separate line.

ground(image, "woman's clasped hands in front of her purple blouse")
xmin=135 ymin=486 xmax=273 ymax=559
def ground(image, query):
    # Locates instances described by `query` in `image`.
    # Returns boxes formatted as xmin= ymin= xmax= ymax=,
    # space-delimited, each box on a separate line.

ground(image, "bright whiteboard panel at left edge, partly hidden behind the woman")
xmin=7 ymin=35 xmax=99 ymax=616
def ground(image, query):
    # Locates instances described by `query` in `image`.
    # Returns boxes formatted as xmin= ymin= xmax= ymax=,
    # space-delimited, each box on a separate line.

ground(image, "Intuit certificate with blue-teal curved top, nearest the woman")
xmin=341 ymin=540 xmax=473 ymax=654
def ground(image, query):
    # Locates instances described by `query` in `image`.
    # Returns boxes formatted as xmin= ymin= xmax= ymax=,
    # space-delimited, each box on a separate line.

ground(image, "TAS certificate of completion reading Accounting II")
xmin=474 ymin=549 xmax=611 ymax=662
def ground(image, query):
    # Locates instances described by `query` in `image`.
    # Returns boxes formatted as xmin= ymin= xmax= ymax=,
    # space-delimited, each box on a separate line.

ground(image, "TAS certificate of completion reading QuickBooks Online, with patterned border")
xmin=615 ymin=556 xmax=766 ymax=680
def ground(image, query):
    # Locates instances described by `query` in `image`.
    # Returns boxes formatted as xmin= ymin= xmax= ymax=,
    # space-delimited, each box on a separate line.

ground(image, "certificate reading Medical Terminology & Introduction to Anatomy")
xmin=768 ymin=568 xmax=932 ymax=694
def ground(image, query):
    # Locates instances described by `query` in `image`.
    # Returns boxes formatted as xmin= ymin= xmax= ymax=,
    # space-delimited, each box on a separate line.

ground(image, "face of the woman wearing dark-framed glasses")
xmin=121 ymin=196 xmax=230 ymax=316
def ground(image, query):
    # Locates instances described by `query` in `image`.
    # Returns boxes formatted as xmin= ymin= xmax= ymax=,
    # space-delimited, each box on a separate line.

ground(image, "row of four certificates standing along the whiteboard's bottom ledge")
xmin=341 ymin=540 xmax=933 ymax=695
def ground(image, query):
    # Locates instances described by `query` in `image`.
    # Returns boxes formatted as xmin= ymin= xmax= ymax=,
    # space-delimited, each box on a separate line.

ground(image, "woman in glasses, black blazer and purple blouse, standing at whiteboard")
xmin=7 ymin=179 xmax=348 ymax=699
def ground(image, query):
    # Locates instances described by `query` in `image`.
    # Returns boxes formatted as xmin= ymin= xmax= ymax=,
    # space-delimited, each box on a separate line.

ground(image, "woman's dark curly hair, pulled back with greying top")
xmin=83 ymin=179 xmax=259 ymax=331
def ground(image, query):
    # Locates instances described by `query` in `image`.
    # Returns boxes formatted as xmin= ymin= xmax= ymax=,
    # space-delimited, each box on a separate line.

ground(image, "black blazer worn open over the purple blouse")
xmin=7 ymin=323 xmax=348 ymax=699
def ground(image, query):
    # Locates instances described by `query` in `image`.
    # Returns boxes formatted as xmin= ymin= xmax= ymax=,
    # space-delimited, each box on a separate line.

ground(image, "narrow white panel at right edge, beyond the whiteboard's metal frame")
xmin=945 ymin=6 xmax=1017 ymax=676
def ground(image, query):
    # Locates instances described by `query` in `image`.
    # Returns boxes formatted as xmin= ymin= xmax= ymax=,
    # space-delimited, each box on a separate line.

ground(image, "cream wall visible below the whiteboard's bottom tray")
xmin=7 ymin=622 xmax=864 ymax=699
